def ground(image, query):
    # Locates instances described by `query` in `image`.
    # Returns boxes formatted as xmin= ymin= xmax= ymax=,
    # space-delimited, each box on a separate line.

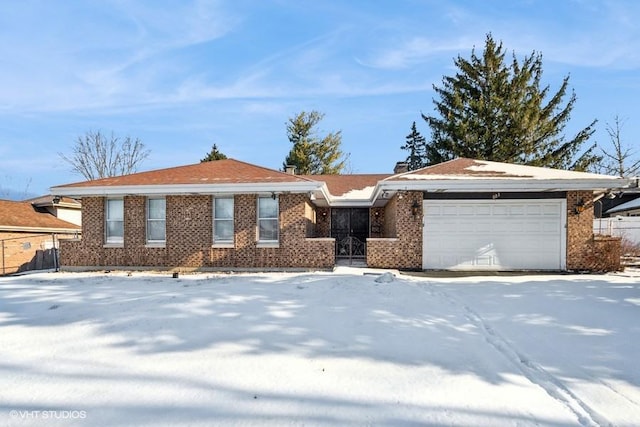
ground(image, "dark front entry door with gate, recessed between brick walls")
xmin=331 ymin=208 xmax=369 ymax=259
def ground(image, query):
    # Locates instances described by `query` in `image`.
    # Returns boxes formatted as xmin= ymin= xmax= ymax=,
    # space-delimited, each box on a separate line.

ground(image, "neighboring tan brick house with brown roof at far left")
xmin=0 ymin=200 xmax=81 ymax=274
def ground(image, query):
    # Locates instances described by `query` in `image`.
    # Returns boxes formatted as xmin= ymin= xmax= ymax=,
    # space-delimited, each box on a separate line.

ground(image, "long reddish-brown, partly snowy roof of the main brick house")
xmin=52 ymin=158 xmax=632 ymax=206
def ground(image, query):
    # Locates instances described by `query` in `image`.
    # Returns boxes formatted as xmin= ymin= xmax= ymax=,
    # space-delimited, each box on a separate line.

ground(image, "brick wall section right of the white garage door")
xmin=567 ymin=191 xmax=621 ymax=271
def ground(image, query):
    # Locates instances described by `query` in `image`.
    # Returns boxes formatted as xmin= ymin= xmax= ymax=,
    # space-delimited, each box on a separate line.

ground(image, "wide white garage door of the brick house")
xmin=422 ymin=199 xmax=566 ymax=270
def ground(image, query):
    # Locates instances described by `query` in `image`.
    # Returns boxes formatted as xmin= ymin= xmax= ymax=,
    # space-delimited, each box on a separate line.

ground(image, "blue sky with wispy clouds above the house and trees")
xmin=0 ymin=0 xmax=640 ymax=197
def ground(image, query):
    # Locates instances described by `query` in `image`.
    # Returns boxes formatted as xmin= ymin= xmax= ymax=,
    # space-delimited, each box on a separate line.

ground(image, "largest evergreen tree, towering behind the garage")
xmin=422 ymin=34 xmax=599 ymax=170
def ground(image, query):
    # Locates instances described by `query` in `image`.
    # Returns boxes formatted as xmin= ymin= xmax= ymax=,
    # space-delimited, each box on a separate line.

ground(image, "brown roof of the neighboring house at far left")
xmin=0 ymin=200 xmax=80 ymax=232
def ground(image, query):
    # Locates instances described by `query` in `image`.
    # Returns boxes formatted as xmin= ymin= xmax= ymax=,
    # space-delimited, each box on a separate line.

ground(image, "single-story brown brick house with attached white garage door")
xmin=52 ymin=158 xmax=631 ymax=271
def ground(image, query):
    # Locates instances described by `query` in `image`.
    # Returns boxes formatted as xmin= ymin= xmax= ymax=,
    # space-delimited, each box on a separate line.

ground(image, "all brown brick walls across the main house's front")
xmin=60 ymin=191 xmax=620 ymax=271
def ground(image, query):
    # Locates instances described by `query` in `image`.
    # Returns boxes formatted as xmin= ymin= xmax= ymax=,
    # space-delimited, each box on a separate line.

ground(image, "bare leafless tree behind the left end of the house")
xmin=58 ymin=131 xmax=150 ymax=180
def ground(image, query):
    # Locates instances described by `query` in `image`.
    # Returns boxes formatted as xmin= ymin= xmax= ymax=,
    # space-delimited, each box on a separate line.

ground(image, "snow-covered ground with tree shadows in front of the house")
xmin=0 ymin=268 xmax=640 ymax=426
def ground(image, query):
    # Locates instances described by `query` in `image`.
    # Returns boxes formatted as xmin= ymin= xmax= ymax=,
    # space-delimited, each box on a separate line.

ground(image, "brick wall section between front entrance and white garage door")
xmin=367 ymin=192 xmax=422 ymax=270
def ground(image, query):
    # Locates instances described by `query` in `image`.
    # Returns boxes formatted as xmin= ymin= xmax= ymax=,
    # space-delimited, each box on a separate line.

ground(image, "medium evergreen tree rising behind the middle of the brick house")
xmin=283 ymin=111 xmax=346 ymax=175
